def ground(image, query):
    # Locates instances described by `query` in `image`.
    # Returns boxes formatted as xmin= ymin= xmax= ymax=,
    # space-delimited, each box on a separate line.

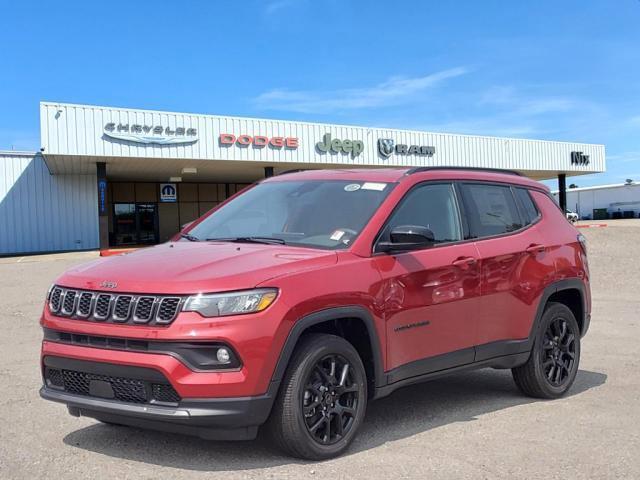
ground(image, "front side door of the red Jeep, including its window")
xmin=374 ymin=182 xmax=480 ymax=374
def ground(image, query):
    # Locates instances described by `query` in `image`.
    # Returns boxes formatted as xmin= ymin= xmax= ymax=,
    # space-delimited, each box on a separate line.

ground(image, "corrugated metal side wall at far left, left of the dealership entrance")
xmin=0 ymin=152 xmax=98 ymax=255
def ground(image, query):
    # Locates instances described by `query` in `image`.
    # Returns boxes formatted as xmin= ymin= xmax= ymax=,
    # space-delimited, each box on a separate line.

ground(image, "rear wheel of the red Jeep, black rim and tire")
xmin=511 ymin=303 xmax=580 ymax=398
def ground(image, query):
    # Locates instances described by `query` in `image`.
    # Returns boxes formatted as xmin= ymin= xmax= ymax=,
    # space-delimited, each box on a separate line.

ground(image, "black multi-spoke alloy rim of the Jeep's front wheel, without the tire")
xmin=301 ymin=355 xmax=359 ymax=445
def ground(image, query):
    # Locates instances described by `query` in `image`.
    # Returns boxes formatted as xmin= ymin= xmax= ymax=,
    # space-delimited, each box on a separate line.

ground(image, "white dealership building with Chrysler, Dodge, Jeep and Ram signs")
xmin=0 ymin=102 xmax=605 ymax=255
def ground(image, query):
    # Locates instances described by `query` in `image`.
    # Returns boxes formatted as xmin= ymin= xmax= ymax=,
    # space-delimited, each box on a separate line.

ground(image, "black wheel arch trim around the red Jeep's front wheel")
xmin=271 ymin=305 xmax=385 ymax=396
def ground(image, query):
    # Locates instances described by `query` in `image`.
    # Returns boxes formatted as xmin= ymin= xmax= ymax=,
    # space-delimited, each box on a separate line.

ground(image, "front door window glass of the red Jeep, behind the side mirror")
xmin=382 ymin=183 xmax=462 ymax=243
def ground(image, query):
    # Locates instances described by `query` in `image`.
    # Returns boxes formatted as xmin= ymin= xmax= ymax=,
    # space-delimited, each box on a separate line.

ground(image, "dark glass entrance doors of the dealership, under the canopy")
xmin=113 ymin=203 xmax=158 ymax=246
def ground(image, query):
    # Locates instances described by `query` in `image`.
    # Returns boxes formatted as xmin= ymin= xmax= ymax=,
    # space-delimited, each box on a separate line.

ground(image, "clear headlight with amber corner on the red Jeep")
xmin=182 ymin=288 xmax=278 ymax=317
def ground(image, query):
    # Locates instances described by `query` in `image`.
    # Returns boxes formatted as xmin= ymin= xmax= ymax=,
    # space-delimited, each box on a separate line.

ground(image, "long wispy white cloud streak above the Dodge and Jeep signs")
xmin=255 ymin=67 xmax=468 ymax=113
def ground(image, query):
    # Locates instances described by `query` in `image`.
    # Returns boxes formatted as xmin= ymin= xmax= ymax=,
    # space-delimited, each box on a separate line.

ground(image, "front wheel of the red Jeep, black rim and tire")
xmin=268 ymin=334 xmax=367 ymax=460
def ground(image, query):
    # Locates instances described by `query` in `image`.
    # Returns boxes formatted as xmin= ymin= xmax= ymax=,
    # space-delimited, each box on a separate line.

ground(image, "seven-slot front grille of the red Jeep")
xmin=49 ymin=286 xmax=186 ymax=325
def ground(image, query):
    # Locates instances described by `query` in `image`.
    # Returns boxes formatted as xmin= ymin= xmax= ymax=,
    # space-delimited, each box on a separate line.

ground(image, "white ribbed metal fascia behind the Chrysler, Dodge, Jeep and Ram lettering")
xmin=40 ymin=102 xmax=605 ymax=174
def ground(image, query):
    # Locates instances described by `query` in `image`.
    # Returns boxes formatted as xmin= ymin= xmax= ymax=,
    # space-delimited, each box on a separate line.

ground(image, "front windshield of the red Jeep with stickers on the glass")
xmin=185 ymin=180 xmax=393 ymax=249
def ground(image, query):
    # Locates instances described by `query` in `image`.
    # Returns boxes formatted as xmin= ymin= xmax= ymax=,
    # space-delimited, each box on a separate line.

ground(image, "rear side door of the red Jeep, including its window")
xmin=461 ymin=183 xmax=555 ymax=346
